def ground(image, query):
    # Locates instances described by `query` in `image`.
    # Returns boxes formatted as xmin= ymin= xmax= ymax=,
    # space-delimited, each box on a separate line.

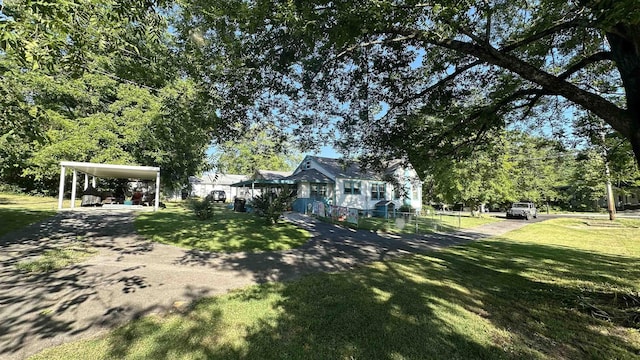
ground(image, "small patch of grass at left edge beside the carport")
xmin=0 ymin=193 xmax=69 ymax=236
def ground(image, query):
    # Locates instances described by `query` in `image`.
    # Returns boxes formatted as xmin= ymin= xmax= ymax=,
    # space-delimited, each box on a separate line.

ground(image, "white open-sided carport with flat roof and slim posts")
xmin=58 ymin=161 xmax=160 ymax=211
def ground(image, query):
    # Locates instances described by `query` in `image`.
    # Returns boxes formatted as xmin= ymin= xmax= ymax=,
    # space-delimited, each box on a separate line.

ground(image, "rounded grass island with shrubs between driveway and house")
xmin=135 ymin=203 xmax=311 ymax=252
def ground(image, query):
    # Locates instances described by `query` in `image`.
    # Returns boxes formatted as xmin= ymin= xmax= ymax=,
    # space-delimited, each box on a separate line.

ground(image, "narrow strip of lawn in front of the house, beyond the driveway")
xmin=358 ymin=215 xmax=502 ymax=234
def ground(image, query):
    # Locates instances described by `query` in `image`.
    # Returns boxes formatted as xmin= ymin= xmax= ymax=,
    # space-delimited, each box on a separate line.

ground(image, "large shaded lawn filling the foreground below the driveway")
xmin=31 ymin=219 xmax=640 ymax=359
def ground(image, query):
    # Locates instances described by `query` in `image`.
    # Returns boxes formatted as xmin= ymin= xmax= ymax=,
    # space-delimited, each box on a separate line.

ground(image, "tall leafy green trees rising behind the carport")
xmin=0 ymin=0 xmax=217 ymax=191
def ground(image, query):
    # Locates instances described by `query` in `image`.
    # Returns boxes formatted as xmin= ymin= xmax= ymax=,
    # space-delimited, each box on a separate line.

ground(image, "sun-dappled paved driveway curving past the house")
xmin=0 ymin=210 xmax=528 ymax=359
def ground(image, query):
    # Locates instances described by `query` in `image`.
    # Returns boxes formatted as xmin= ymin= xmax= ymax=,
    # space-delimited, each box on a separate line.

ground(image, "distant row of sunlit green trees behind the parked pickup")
xmin=423 ymin=131 xmax=640 ymax=211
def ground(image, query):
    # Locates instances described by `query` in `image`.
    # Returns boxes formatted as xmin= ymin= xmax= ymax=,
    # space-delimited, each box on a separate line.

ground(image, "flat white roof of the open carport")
xmin=60 ymin=161 xmax=160 ymax=180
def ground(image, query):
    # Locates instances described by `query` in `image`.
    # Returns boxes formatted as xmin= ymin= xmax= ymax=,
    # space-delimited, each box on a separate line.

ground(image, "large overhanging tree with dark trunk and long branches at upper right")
xmin=182 ymin=0 xmax=640 ymax=170
